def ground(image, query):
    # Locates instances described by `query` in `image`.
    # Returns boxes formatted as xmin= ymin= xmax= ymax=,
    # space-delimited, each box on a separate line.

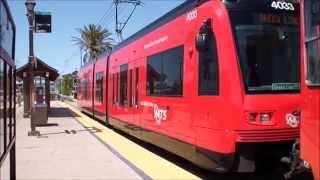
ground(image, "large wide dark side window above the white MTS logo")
xmin=147 ymin=46 xmax=183 ymax=96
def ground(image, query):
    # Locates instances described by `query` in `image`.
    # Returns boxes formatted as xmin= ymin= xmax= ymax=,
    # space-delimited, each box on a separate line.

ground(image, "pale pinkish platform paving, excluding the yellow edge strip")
xmin=17 ymin=102 xmax=142 ymax=179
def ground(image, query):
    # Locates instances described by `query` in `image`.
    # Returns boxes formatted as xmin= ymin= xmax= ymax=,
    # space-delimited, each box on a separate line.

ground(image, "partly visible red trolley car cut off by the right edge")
xmin=301 ymin=0 xmax=320 ymax=180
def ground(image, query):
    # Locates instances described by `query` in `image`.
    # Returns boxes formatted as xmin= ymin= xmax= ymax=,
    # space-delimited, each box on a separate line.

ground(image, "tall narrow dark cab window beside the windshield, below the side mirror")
xmin=198 ymin=30 xmax=219 ymax=95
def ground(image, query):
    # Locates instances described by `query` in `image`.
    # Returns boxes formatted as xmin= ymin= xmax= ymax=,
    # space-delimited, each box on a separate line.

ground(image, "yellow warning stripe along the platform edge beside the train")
xmin=61 ymin=102 xmax=200 ymax=180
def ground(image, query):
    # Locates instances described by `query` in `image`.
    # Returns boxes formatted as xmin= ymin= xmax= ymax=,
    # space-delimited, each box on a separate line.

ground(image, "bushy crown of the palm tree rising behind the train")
xmin=72 ymin=24 xmax=113 ymax=63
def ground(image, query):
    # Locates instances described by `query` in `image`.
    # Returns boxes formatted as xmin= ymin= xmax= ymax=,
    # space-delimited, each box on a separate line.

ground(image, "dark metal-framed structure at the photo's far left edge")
xmin=0 ymin=0 xmax=16 ymax=180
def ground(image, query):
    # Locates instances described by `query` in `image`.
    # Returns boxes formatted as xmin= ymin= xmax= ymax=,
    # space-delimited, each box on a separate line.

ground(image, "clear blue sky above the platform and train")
xmin=8 ymin=0 xmax=183 ymax=74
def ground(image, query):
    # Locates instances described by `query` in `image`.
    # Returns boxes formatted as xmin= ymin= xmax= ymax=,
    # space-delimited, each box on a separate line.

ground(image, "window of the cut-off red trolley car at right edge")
xmin=305 ymin=0 xmax=320 ymax=86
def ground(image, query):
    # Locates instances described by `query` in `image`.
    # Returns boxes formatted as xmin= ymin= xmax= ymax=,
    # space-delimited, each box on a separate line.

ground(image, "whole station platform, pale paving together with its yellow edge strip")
xmin=16 ymin=101 xmax=200 ymax=179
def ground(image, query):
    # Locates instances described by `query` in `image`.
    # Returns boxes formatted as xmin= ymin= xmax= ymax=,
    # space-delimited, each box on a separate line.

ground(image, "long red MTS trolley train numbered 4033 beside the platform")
xmin=78 ymin=0 xmax=300 ymax=172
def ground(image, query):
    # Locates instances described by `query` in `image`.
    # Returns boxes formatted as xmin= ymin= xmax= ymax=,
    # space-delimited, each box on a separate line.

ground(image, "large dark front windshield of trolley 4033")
xmin=229 ymin=1 xmax=300 ymax=94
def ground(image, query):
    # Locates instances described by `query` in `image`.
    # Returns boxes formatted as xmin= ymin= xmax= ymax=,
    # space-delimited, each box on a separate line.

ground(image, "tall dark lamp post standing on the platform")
xmin=25 ymin=0 xmax=37 ymax=135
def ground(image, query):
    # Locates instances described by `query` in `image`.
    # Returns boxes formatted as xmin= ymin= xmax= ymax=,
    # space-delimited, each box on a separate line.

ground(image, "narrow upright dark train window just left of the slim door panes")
xmin=120 ymin=64 xmax=128 ymax=106
